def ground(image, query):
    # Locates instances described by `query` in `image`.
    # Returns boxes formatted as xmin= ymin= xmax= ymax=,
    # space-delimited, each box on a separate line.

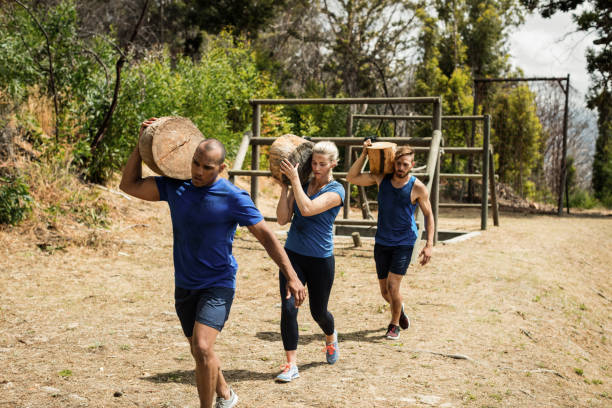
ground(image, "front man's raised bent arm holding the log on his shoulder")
xmin=119 ymin=118 xmax=159 ymax=201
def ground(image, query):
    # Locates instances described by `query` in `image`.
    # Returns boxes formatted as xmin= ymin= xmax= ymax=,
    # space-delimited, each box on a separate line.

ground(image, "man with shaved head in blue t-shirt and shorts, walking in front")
xmin=120 ymin=118 xmax=306 ymax=408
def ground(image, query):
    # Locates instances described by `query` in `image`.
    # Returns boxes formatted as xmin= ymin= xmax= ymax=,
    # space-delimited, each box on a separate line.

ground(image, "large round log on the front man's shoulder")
xmin=138 ymin=116 xmax=204 ymax=180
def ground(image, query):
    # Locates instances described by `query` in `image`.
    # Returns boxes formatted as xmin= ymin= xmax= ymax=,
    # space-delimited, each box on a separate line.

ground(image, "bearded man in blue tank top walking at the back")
xmin=346 ymin=139 xmax=434 ymax=340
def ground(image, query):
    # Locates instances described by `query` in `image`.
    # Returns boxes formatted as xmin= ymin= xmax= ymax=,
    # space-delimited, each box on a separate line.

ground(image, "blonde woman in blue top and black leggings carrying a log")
xmin=276 ymin=142 xmax=344 ymax=382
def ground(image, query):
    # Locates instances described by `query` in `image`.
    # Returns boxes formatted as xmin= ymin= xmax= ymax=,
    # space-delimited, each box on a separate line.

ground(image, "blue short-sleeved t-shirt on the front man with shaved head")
xmin=155 ymin=177 xmax=263 ymax=290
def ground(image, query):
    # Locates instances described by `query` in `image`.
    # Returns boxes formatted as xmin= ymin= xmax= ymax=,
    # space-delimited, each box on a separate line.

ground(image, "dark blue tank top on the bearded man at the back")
xmin=376 ymin=174 xmax=418 ymax=246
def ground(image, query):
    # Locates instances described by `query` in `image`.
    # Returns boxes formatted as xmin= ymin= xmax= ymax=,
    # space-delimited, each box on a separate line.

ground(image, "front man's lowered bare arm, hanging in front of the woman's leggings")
xmin=247 ymin=220 xmax=306 ymax=307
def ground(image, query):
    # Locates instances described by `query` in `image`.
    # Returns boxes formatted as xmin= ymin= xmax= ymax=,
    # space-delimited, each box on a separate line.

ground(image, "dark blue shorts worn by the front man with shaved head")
xmin=174 ymin=287 xmax=235 ymax=337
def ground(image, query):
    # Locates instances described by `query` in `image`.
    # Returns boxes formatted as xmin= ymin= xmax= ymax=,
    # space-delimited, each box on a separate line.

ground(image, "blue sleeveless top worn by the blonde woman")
xmin=285 ymin=180 xmax=344 ymax=258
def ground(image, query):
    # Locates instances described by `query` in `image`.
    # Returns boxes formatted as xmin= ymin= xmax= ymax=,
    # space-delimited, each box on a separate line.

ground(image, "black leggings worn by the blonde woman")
xmin=279 ymin=249 xmax=335 ymax=350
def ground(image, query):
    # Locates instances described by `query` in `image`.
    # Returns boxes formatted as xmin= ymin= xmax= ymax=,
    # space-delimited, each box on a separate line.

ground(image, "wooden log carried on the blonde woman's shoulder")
xmin=268 ymin=134 xmax=314 ymax=184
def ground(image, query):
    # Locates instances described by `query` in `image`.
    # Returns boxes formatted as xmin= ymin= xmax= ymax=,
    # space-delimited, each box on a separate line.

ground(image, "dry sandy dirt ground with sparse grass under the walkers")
xmin=0 ymin=176 xmax=612 ymax=407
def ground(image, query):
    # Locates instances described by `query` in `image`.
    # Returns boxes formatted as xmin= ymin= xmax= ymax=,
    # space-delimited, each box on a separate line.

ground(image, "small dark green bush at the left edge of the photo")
xmin=0 ymin=176 xmax=32 ymax=225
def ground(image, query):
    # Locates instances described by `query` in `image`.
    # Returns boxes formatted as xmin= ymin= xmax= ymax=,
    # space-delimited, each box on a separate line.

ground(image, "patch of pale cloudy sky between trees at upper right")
xmin=510 ymin=8 xmax=593 ymax=100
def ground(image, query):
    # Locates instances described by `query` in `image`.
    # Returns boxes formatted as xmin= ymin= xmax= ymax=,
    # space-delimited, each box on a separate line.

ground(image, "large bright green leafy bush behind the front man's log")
xmin=86 ymin=33 xmax=288 ymax=181
